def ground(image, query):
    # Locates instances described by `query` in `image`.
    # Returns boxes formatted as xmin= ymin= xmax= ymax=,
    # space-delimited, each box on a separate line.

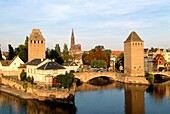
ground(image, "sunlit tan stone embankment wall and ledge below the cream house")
xmin=0 ymin=77 xmax=74 ymax=101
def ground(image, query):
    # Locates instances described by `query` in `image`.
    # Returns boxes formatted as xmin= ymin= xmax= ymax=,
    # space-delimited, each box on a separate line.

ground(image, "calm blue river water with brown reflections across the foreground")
xmin=0 ymin=82 xmax=170 ymax=114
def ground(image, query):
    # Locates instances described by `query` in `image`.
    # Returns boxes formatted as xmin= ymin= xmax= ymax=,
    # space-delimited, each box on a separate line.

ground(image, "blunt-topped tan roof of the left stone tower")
xmin=30 ymin=29 xmax=45 ymax=40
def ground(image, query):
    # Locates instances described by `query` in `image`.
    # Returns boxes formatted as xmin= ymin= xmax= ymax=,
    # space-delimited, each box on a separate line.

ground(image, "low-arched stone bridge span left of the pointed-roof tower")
xmin=74 ymin=72 xmax=116 ymax=82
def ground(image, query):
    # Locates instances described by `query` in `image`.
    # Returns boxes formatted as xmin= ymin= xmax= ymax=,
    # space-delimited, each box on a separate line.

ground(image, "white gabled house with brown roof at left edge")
xmin=0 ymin=56 xmax=24 ymax=76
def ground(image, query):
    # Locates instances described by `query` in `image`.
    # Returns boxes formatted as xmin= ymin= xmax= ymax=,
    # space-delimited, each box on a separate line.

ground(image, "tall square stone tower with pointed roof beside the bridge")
xmin=124 ymin=32 xmax=144 ymax=76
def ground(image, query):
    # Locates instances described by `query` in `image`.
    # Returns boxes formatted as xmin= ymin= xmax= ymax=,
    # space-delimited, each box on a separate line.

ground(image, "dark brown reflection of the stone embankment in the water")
xmin=0 ymin=92 xmax=76 ymax=114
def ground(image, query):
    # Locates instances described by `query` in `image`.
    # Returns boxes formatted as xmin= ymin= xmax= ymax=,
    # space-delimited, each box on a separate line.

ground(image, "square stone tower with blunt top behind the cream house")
xmin=28 ymin=29 xmax=45 ymax=61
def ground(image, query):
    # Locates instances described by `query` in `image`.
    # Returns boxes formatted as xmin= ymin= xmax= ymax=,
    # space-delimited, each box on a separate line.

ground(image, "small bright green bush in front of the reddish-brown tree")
xmin=91 ymin=59 xmax=107 ymax=68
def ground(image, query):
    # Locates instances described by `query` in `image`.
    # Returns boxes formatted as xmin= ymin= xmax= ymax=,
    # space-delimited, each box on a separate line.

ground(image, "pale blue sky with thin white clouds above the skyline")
xmin=0 ymin=0 xmax=170 ymax=51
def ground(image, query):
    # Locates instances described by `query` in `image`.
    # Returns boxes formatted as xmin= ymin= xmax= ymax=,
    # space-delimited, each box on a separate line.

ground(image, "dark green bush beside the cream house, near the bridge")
xmin=56 ymin=73 xmax=74 ymax=88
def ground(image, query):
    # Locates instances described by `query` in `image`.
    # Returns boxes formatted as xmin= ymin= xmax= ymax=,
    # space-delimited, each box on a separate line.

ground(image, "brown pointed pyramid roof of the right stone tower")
xmin=124 ymin=31 xmax=143 ymax=43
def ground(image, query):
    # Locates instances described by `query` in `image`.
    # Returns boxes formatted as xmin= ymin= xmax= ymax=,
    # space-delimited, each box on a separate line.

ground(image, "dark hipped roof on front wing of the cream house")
xmin=37 ymin=62 xmax=65 ymax=70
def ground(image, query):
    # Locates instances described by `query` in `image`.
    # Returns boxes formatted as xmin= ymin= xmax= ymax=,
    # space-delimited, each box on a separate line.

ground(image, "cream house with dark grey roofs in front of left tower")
xmin=26 ymin=59 xmax=66 ymax=83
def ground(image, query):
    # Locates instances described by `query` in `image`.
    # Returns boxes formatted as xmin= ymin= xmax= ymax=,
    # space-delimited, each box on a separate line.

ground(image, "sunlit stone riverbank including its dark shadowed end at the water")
xmin=0 ymin=77 xmax=74 ymax=104
